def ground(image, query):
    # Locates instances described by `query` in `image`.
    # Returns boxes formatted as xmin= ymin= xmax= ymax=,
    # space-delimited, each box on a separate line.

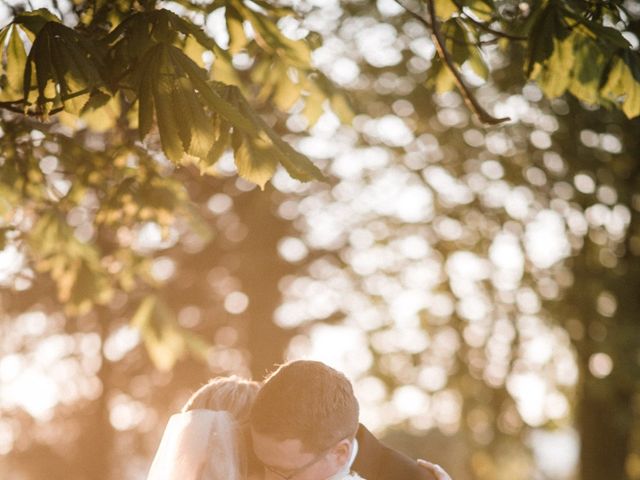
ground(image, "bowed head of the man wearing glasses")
xmin=251 ymin=360 xmax=358 ymax=480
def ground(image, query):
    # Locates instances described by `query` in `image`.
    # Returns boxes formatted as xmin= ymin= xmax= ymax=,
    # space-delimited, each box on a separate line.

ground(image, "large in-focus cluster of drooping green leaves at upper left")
xmin=0 ymin=5 xmax=340 ymax=187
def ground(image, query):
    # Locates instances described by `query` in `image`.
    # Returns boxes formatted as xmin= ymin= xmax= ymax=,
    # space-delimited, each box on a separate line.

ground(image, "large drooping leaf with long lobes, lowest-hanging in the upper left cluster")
xmin=130 ymin=44 xmax=324 ymax=187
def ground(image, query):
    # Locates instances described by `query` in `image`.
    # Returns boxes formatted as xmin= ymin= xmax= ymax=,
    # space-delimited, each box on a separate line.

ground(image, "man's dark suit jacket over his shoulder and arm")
xmin=351 ymin=425 xmax=436 ymax=480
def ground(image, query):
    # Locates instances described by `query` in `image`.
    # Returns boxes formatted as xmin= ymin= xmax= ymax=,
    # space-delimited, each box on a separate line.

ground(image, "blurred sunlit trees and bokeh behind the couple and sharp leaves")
xmin=0 ymin=0 xmax=640 ymax=480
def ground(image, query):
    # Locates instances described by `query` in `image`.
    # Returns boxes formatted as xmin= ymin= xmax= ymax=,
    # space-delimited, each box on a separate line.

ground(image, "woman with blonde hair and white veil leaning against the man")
xmin=147 ymin=376 xmax=260 ymax=480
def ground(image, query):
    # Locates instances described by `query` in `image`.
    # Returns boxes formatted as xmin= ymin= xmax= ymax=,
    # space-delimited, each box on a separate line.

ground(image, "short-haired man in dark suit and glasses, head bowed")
xmin=251 ymin=360 xmax=450 ymax=480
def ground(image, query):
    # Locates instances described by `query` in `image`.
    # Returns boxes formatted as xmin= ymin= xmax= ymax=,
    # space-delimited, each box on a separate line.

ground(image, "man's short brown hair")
xmin=251 ymin=360 xmax=359 ymax=452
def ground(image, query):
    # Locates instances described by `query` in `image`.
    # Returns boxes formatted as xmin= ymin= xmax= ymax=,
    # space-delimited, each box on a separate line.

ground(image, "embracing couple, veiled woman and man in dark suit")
xmin=147 ymin=360 xmax=451 ymax=480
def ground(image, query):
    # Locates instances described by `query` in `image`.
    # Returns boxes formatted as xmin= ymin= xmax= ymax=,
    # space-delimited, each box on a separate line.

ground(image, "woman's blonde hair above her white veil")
xmin=182 ymin=375 xmax=260 ymax=425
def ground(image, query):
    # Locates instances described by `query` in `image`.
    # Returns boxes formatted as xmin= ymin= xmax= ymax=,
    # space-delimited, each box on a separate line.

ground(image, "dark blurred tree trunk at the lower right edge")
xmin=571 ymin=233 xmax=640 ymax=480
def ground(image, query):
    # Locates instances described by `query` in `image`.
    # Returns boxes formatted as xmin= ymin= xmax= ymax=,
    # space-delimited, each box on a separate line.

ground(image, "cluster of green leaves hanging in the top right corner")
xmin=418 ymin=0 xmax=640 ymax=118
